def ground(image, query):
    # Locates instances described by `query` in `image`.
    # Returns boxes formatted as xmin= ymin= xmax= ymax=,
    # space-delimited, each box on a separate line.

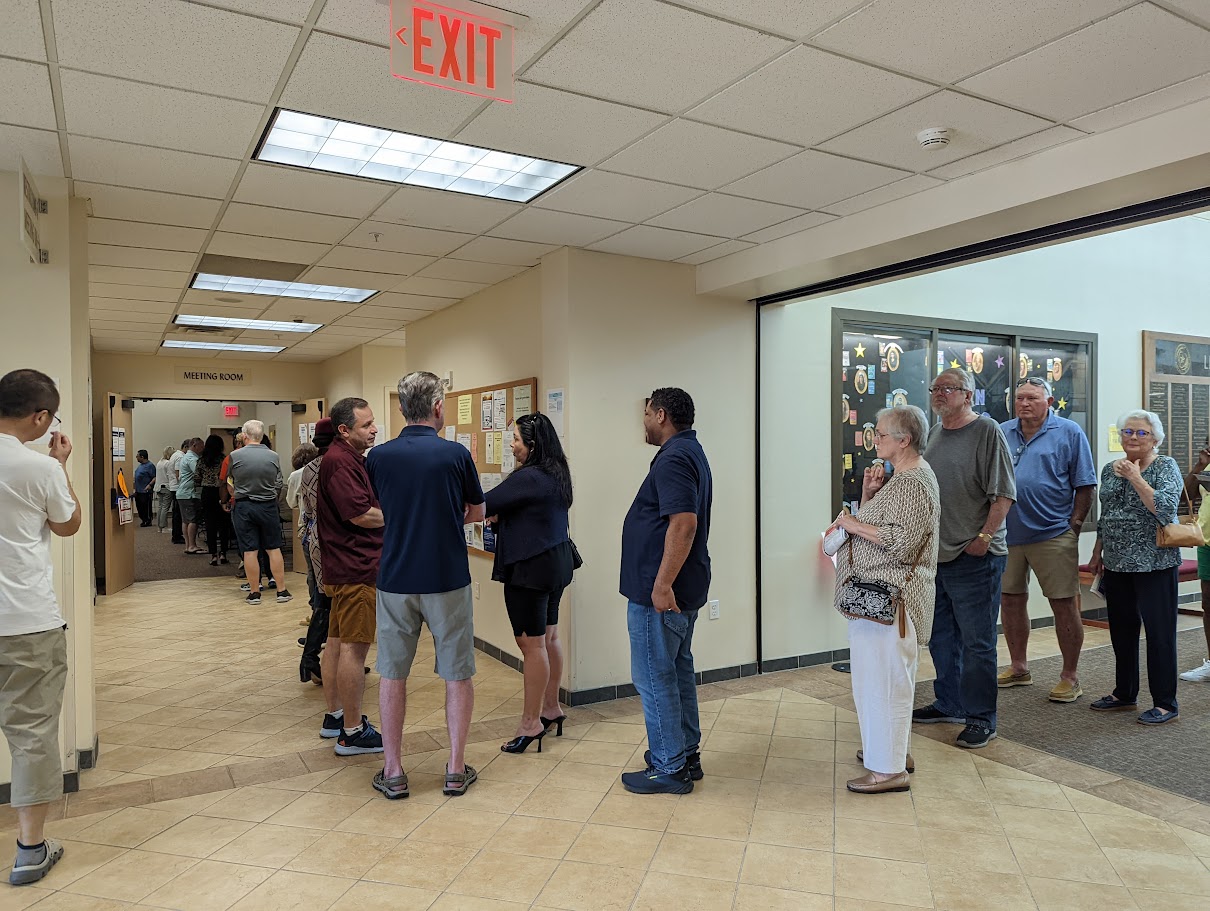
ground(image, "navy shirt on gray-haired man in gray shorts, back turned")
xmin=365 ymin=425 xmax=483 ymax=594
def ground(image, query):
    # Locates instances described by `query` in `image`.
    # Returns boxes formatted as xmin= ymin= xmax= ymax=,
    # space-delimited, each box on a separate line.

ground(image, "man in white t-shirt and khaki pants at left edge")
xmin=0 ymin=370 xmax=81 ymax=886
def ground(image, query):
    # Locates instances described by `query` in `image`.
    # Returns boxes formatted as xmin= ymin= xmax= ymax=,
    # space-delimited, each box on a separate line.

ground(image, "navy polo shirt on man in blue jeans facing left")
xmin=620 ymin=431 xmax=713 ymax=611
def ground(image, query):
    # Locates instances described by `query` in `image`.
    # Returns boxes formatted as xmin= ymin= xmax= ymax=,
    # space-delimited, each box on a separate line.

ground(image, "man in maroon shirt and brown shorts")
xmin=316 ymin=398 xmax=382 ymax=756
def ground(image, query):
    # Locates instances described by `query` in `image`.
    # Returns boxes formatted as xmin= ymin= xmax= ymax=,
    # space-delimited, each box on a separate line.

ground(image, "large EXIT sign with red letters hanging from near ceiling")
xmin=391 ymin=0 xmax=513 ymax=103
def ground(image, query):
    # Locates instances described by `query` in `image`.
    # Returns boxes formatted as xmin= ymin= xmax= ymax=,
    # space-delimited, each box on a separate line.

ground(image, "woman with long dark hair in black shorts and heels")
xmin=485 ymin=414 xmax=576 ymax=753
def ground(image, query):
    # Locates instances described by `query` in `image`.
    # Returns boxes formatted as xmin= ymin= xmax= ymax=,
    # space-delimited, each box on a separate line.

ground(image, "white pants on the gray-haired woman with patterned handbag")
xmin=848 ymin=616 xmax=920 ymax=774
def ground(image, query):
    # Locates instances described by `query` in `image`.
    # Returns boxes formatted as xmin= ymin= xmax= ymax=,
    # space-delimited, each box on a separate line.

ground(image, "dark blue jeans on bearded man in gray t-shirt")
xmin=928 ymin=553 xmax=1007 ymax=731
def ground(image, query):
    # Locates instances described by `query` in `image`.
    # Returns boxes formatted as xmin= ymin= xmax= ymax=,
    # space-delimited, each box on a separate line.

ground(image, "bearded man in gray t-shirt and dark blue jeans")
xmin=912 ymin=368 xmax=1016 ymax=749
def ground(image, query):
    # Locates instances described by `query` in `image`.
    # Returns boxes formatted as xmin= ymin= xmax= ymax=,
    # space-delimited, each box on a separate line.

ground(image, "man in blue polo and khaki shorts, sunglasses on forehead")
xmin=996 ymin=376 xmax=1096 ymax=702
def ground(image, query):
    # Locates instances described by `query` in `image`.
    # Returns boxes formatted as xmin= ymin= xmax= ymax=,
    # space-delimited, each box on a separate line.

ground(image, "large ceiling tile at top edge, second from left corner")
xmin=54 ymin=0 xmax=299 ymax=102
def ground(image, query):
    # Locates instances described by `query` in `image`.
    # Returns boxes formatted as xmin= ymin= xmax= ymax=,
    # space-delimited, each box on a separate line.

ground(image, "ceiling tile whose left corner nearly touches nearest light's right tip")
xmin=601 ymin=120 xmax=797 ymax=190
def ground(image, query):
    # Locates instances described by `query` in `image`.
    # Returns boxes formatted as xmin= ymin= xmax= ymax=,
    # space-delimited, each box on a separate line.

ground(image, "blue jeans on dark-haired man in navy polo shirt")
xmin=626 ymin=601 xmax=702 ymax=773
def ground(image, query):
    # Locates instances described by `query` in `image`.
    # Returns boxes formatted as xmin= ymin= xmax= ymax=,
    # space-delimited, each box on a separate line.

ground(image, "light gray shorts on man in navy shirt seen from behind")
xmin=376 ymin=586 xmax=474 ymax=680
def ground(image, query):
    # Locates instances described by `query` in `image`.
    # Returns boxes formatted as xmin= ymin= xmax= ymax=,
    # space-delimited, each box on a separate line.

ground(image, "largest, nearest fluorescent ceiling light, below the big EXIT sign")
xmin=255 ymin=108 xmax=580 ymax=202
